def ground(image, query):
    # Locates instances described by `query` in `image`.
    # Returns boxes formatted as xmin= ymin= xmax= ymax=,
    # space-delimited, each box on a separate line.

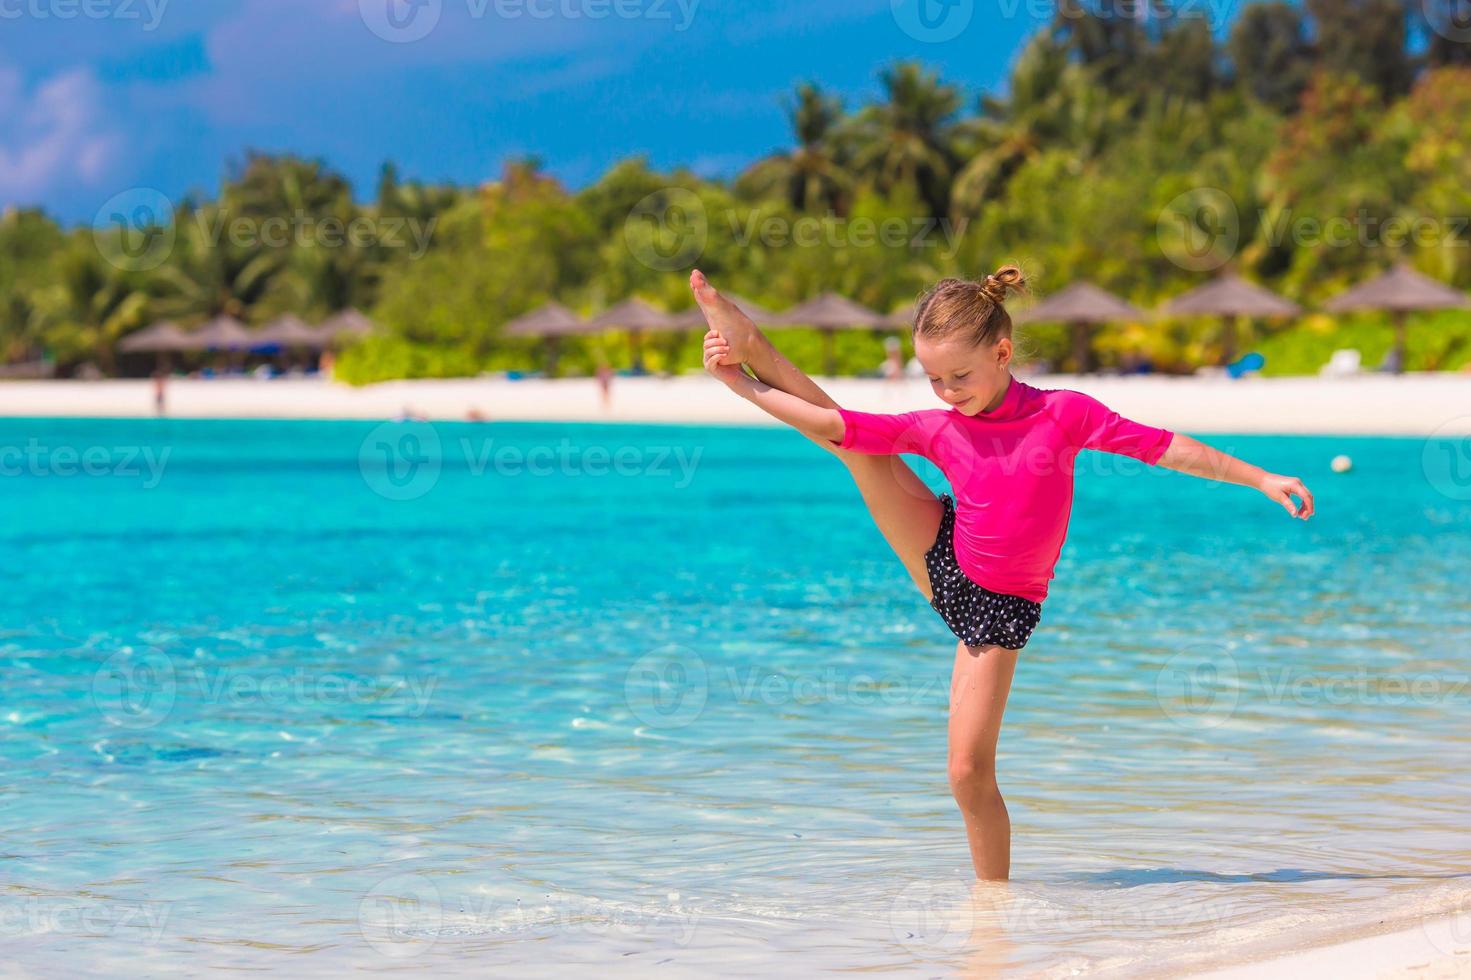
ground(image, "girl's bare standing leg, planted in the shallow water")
xmin=949 ymin=643 xmax=1016 ymax=880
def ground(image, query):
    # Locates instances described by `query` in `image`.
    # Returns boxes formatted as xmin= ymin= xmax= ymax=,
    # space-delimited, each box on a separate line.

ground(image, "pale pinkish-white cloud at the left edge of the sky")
xmin=0 ymin=66 xmax=122 ymax=205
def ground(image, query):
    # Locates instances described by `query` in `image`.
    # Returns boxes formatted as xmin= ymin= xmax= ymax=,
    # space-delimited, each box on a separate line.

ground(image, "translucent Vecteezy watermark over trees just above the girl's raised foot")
xmin=624 ymin=187 xmax=968 ymax=272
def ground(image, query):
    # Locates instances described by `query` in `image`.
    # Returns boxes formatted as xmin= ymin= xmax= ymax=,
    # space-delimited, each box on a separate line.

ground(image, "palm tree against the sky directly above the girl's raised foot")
xmin=740 ymin=82 xmax=853 ymax=213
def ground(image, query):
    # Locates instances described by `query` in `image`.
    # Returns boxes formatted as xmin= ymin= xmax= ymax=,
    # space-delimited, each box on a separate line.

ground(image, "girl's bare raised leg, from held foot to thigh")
xmin=690 ymin=272 xmax=944 ymax=600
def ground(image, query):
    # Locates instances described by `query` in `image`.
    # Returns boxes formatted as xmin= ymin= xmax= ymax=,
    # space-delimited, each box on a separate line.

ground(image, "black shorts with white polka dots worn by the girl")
xmin=924 ymin=493 xmax=1041 ymax=650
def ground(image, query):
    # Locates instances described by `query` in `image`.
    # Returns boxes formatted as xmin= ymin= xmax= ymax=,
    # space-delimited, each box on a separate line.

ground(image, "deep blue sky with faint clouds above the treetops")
xmin=0 ymin=0 xmax=1241 ymax=222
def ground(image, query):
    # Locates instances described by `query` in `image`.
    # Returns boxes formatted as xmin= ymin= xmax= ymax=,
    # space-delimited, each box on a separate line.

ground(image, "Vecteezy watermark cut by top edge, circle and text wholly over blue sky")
xmin=357 ymin=0 xmax=700 ymax=44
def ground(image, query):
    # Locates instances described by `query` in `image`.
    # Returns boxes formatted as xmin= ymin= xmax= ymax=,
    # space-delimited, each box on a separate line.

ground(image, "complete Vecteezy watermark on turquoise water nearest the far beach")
xmin=357 ymin=422 xmax=705 ymax=500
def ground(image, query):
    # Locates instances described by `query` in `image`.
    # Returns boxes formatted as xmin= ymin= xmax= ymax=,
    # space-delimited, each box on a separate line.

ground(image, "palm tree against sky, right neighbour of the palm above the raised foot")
xmin=853 ymin=62 xmax=962 ymax=215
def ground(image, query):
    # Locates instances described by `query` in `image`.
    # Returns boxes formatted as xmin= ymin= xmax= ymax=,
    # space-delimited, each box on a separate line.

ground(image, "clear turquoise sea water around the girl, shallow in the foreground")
xmin=0 ymin=421 xmax=1471 ymax=976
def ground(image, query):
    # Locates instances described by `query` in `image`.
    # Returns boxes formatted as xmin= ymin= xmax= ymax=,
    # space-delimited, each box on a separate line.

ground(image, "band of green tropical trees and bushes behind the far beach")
xmin=0 ymin=0 xmax=1471 ymax=383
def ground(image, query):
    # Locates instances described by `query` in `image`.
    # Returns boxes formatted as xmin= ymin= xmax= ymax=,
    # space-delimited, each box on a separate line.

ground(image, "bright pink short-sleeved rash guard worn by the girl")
xmin=838 ymin=378 xmax=1174 ymax=602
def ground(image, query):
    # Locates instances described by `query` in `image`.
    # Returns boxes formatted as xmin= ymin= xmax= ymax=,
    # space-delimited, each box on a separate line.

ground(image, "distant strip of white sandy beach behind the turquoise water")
xmin=0 ymin=374 xmax=1471 ymax=437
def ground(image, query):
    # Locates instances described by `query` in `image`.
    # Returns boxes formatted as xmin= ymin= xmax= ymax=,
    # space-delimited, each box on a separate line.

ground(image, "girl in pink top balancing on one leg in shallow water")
xmin=690 ymin=266 xmax=1314 ymax=880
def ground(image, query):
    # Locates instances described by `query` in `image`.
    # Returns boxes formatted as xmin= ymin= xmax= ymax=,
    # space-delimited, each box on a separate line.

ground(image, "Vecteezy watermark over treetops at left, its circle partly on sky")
xmin=93 ymin=187 xmax=438 ymax=272
